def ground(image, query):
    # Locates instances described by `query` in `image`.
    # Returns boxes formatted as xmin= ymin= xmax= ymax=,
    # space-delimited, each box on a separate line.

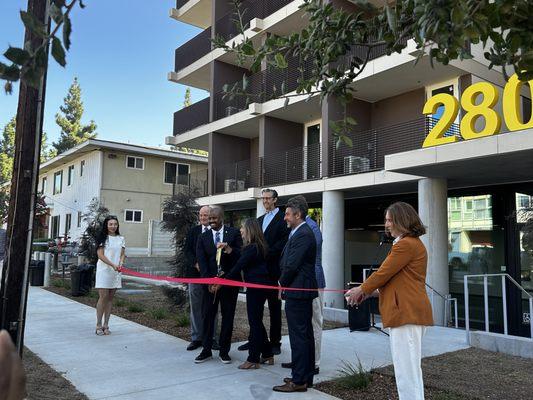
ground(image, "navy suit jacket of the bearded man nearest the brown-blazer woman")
xmin=279 ymin=223 xmax=318 ymax=299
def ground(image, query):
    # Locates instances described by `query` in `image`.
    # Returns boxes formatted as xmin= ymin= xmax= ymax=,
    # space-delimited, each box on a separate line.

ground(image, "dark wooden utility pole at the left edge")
xmin=0 ymin=0 xmax=49 ymax=355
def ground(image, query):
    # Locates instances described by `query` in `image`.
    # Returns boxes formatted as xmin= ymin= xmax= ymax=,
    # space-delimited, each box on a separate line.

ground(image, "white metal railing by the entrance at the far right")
xmin=464 ymin=274 xmax=533 ymax=344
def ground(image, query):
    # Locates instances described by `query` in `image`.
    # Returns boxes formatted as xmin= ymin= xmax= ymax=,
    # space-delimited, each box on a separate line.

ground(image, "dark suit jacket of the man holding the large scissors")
xmin=196 ymin=225 xmax=242 ymax=278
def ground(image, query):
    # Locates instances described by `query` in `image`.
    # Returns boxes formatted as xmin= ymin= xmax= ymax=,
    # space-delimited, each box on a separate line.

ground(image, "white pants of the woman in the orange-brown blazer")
xmin=390 ymin=325 xmax=426 ymax=400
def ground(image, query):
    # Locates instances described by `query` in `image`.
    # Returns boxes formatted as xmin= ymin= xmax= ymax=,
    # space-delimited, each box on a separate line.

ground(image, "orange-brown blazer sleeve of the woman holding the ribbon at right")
xmin=361 ymin=240 xmax=413 ymax=294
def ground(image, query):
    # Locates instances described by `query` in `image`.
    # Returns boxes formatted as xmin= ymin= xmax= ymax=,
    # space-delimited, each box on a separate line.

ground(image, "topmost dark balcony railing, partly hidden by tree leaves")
xmin=215 ymin=0 xmax=294 ymax=41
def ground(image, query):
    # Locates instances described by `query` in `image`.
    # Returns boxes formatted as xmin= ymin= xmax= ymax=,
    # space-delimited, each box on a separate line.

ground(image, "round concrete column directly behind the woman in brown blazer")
xmin=418 ymin=178 xmax=450 ymax=325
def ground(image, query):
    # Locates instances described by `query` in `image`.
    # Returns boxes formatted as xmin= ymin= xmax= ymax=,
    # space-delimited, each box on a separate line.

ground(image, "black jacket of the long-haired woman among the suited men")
xmin=226 ymin=243 xmax=270 ymax=285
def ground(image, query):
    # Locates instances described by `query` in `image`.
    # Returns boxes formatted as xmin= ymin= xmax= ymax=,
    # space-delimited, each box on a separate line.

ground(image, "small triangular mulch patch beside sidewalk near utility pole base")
xmin=23 ymin=348 xmax=88 ymax=400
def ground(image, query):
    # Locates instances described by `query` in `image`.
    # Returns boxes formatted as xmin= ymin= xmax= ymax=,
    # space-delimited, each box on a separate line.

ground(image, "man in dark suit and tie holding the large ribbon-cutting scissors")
xmin=194 ymin=206 xmax=242 ymax=364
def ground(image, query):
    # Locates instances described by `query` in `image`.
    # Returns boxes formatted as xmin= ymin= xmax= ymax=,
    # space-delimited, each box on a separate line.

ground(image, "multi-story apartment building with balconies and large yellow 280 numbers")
xmin=167 ymin=0 xmax=533 ymax=333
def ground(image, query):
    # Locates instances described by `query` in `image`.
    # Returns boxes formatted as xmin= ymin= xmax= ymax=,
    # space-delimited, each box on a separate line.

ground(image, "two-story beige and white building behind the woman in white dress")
xmin=38 ymin=139 xmax=207 ymax=255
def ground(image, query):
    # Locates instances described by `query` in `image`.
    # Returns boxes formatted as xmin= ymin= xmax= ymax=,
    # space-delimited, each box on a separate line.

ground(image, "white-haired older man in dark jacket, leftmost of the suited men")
xmin=184 ymin=206 xmax=210 ymax=351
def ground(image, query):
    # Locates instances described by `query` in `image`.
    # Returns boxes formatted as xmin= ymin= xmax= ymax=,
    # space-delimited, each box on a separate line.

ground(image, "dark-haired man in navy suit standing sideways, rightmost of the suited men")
xmin=273 ymin=196 xmax=318 ymax=393
